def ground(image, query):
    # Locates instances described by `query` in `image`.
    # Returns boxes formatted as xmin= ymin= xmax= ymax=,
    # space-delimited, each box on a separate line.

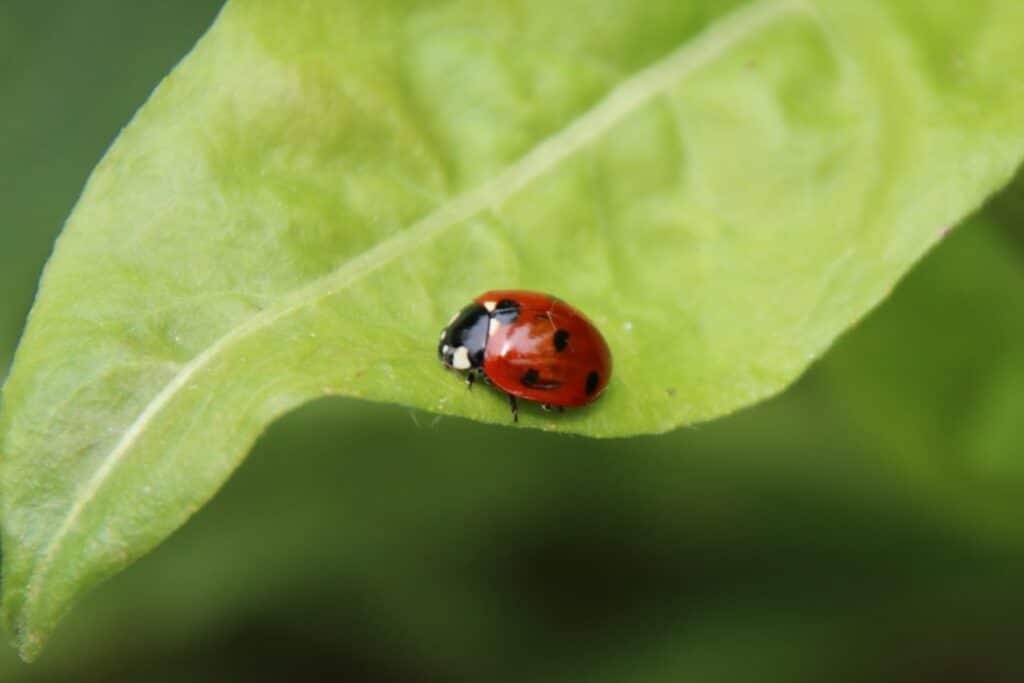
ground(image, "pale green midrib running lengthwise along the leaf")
xmin=23 ymin=0 xmax=808 ymax=630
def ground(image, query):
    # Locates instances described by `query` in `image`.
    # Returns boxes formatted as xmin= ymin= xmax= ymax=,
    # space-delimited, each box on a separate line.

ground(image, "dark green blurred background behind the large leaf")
xmin=0 ymin=0 xmax=1024 ymax=683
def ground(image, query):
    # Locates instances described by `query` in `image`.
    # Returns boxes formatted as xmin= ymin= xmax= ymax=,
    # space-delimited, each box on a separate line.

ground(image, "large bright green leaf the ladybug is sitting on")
xmin=0 ymin=0 xmax=1024 ymax=657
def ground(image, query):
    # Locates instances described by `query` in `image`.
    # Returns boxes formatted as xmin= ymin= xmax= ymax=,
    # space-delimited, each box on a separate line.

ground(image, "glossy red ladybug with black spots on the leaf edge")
xmin=437 ymin=290 xmax=611 ymax=422
